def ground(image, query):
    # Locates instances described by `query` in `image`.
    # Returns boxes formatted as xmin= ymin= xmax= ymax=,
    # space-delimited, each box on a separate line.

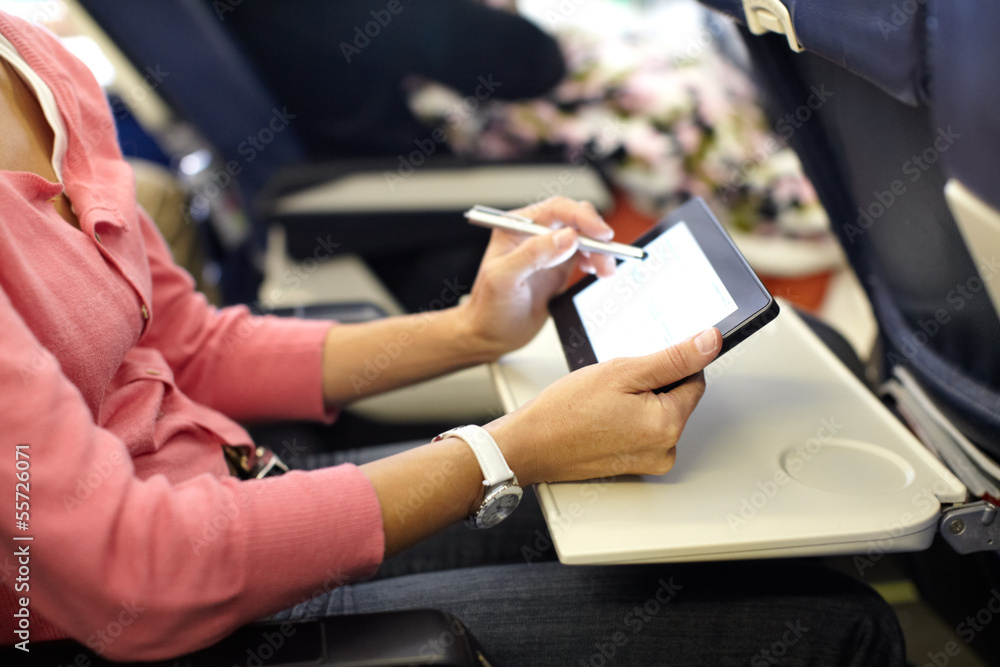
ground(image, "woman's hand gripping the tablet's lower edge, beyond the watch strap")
xmin=485 ymin=329 xmax=722 ymax=486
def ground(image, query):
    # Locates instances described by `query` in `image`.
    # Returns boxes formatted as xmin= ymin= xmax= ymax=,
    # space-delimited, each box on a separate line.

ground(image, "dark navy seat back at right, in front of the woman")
xmin=706 ymin=0 xmax=1000 ymax=456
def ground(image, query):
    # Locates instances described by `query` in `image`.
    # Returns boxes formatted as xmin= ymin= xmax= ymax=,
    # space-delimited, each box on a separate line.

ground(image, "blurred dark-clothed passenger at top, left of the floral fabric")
xmin=205 ymin=0 xmax=566 ymax=157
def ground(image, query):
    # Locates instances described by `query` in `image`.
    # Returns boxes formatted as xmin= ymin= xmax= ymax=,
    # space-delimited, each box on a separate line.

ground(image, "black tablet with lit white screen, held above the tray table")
xmin=549 ymin=198 xmax=778 ymax=370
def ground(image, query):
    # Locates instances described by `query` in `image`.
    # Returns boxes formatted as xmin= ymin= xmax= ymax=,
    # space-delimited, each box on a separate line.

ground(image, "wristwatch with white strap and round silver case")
xmin=433 ymin=426 xmax=522 ymax=528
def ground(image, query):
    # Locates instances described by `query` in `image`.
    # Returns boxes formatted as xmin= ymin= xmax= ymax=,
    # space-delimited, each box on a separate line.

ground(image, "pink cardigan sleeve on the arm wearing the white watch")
xmin=0 ymin=280 xmax=384 ymax=660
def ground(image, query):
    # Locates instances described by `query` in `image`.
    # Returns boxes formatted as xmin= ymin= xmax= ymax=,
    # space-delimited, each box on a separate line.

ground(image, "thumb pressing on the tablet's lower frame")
xmin=622 ymin=327 xmax=722 ymax=391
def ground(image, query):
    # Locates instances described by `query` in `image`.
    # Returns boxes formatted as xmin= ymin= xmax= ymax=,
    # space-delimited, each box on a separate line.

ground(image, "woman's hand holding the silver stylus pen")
xmin=459 ymin=197 xmax=615 ymax=356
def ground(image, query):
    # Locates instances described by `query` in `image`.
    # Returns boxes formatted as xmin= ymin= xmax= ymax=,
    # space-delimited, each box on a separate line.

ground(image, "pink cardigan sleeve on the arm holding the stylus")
xmin=139 ymin=209 xmax=335 ymax=421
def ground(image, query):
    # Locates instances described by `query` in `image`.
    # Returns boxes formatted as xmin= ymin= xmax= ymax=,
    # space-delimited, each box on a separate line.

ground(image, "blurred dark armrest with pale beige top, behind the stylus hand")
xmin=255 ymin=154 xmax=612 ymax=260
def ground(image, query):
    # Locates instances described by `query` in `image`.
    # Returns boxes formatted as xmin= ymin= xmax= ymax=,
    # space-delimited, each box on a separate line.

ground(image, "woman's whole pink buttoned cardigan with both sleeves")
xmin=0 ymin=13 xmax=384 ymax=660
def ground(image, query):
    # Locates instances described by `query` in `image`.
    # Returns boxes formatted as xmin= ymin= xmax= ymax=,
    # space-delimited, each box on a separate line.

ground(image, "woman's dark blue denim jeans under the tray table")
xmin=276 ymin=445 xmax=905 ymax=667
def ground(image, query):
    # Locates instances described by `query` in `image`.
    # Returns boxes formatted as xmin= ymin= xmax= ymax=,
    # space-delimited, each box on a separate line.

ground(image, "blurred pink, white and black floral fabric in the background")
xmin=411 ymin=6 xmax=832 ymax=247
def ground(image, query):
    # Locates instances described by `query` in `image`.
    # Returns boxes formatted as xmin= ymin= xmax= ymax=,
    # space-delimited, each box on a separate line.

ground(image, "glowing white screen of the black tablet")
xmin=573 ymin=221 xmax=737 ymax=361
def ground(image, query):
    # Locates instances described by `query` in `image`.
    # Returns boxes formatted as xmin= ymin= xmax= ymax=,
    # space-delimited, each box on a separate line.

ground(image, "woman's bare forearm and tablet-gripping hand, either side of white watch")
xmin=361 ymin=329 xmax=722 ymax=555
